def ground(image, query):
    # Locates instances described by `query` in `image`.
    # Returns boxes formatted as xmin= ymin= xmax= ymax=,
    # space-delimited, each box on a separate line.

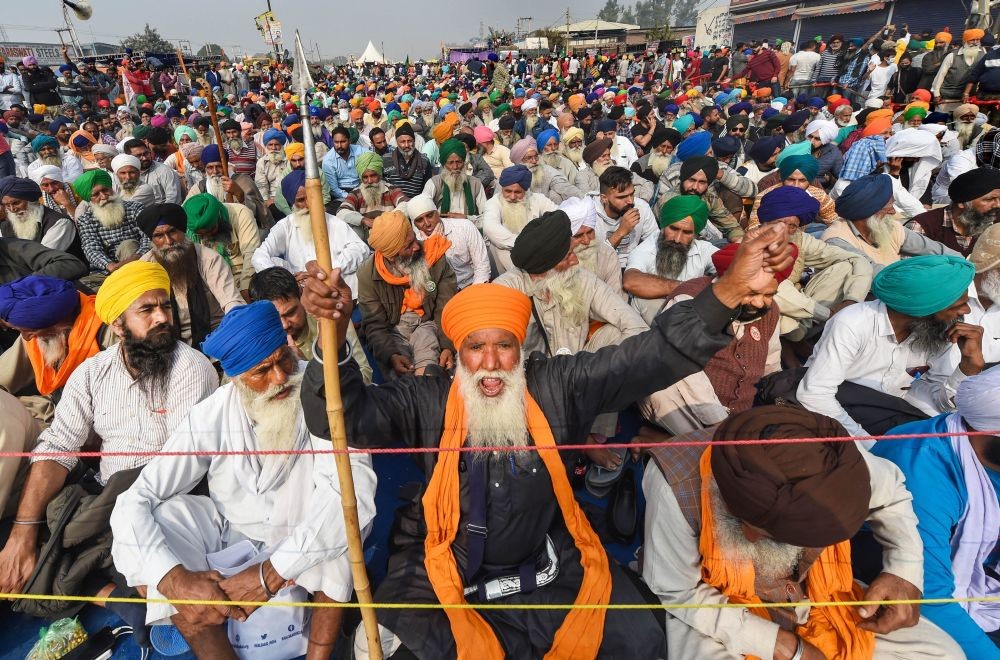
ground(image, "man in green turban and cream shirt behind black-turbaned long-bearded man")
xmin=184 ymin=193 xmax=260 ymax=300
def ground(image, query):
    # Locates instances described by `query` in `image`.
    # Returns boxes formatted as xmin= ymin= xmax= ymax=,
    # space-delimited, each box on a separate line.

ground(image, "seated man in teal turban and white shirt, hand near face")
xmin=796 ymin=256 xmax=984 ymax=446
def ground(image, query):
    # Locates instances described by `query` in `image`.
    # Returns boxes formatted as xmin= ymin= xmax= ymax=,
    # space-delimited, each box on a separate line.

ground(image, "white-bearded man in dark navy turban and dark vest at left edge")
xmin=0 ymin=176 xmax=83 ymax=259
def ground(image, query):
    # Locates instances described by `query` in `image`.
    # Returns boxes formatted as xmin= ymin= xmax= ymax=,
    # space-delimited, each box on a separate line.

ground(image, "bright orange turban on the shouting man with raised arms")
xmin=441 ymin=283 xmax=531 ymax=348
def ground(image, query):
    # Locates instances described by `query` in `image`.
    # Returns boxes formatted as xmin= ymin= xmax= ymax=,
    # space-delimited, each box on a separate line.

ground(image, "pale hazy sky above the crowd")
xmin=0 ymin=0 xmax=640 ymax=60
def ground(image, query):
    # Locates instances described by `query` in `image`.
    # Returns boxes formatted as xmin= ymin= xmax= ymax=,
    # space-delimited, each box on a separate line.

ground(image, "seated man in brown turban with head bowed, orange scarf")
xmin=642 ymin=406 xmax=964 ymax=660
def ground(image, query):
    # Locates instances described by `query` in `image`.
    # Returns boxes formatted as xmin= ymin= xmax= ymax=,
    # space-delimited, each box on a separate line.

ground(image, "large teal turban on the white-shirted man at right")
xmin=872 ymin=256 xmax=976 ymax=318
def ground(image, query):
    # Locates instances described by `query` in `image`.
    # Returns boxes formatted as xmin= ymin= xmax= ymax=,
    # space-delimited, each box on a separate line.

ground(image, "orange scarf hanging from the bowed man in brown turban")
xmin=698 ymin=447 xmax=875 ymax=660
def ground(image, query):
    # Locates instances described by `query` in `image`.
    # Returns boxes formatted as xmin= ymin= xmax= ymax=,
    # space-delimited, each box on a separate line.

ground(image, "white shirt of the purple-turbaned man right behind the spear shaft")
xmin=251 ymin=213 xmax=371 ymax=296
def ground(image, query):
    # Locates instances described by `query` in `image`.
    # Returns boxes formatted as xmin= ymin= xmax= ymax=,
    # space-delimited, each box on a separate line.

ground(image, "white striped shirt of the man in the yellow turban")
xmin=31 ymin=342 xmax=219 ymax=484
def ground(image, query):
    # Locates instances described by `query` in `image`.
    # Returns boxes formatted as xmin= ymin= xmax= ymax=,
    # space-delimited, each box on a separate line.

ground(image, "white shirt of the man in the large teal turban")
xmin=797 ymin=300 xmax=965 ymax=447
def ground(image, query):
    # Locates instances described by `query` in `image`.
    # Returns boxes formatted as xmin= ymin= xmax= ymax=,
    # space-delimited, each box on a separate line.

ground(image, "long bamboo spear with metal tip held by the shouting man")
xmin=288 ymin=31 xmax=382 ymax=660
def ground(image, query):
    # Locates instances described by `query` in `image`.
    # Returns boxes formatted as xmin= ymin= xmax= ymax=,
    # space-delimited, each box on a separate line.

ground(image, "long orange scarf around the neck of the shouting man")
xmin=423 ymin=381 xmax=611 ymax=660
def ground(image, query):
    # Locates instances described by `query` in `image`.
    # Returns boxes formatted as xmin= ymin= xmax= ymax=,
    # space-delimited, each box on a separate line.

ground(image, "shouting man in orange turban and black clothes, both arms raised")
xmin=302 ymin=223 xmax=792 ymax=660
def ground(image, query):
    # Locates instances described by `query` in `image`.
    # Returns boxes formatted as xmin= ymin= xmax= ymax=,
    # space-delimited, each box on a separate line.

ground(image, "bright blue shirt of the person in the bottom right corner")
xmin=871 ymin=414 xmax=1000 ymax=660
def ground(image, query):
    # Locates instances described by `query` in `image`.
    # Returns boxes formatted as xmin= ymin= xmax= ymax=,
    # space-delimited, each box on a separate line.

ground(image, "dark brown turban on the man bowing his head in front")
xmin=712 ymin=406 xmax=871 ymax=548
